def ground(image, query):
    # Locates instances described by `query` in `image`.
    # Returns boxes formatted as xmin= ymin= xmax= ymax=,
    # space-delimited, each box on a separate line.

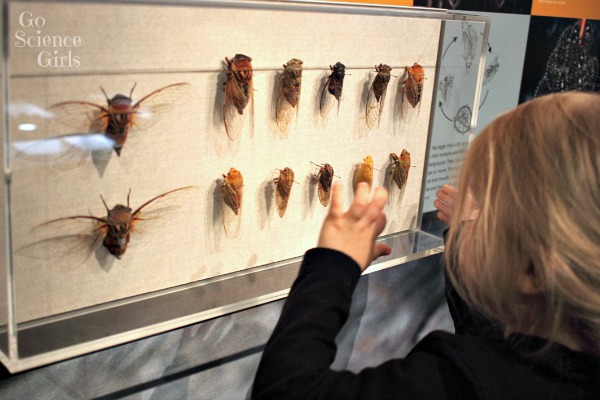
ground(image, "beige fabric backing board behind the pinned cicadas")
xmin=8 ymin=3 xmax=441 ymax=321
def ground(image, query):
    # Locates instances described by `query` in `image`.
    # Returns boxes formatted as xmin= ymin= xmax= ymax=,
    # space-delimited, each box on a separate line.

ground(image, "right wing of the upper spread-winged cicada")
xmin=131 ymin=82 xmax=191 ymax=130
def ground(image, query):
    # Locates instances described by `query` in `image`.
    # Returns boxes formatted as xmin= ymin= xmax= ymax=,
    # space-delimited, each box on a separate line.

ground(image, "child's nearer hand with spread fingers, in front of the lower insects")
xmin=318 ymin=182 xmax=391 ymax=271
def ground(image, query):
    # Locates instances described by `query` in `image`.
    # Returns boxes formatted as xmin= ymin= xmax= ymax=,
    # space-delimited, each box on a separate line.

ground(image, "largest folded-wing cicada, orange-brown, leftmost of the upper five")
xmin=223 ymin=54 xmax=254 ymax=140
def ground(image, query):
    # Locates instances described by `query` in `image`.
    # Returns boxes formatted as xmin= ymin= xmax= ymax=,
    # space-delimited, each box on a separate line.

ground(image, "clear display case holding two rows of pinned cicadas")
xmin=0 ymin=1 xmax=489 ymax=372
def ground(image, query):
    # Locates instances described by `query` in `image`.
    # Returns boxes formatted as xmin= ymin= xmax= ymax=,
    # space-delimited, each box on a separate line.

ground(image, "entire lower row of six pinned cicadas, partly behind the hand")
xmin=18 ymin=150 xmax=410 ymax=259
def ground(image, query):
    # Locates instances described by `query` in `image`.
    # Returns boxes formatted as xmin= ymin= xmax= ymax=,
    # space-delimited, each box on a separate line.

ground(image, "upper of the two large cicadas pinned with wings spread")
xmin=50 ymin=83 xmax=190 ymax=156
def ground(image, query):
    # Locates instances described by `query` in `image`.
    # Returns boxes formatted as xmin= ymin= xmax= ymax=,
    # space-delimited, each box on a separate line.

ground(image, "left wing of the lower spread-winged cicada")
xmin=15 ymin=216 xmax=107 ymax=265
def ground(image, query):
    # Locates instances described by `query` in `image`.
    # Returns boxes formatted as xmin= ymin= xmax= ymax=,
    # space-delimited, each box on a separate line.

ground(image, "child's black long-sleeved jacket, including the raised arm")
xmin=252 ymin=248 xmax=600 ymax=400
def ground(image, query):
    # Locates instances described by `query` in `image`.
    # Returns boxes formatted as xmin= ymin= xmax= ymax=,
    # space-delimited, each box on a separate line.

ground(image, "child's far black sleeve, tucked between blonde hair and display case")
xmin=442 ymin=230 xmax=504 ymax=338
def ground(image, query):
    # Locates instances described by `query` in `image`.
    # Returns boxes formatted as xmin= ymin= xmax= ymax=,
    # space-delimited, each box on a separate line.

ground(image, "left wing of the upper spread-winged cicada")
xmin=49 ymin=101 xmax=108 ymax=133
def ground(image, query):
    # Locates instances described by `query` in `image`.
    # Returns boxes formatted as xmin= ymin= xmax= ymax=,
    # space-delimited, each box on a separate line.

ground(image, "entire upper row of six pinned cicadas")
xmin=25 ymin=54 xmax=425 ymax=159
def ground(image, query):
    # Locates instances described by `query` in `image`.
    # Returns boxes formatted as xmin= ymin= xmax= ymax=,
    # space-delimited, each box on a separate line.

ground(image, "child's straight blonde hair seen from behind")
xmin=446 ymin=93 xmax=600 ymax=354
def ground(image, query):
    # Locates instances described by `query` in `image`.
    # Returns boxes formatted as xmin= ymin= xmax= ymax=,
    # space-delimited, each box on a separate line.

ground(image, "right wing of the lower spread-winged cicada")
xmin=131 ymin=186 xmax=198 ymax=233
